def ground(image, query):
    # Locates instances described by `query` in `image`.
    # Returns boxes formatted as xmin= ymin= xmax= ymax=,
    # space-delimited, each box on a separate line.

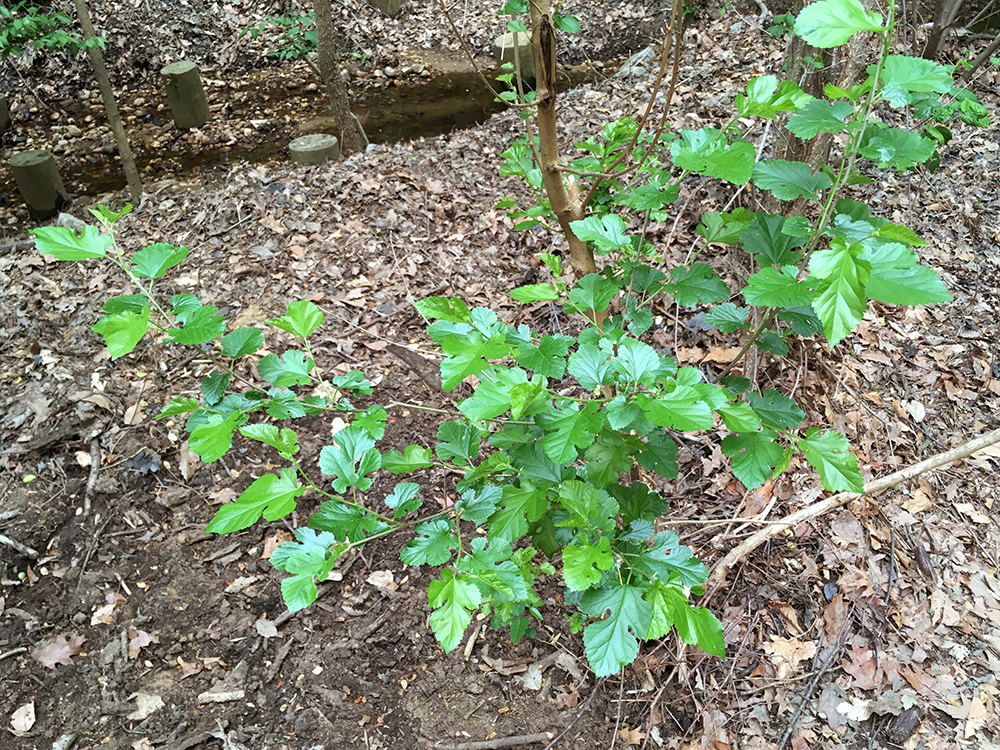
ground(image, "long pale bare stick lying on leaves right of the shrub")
xmin=708 ymin=430 xmax=1000 ymax=584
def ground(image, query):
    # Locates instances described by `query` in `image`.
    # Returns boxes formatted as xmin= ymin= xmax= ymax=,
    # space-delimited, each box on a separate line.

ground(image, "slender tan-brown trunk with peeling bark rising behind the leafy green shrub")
xmin=531 ymin=0 xmax=597 ymax=277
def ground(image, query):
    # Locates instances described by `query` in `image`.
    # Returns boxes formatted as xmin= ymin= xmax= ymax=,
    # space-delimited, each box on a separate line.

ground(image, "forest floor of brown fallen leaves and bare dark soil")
xmin=0 ymin=0 xmax=1000 ymax=750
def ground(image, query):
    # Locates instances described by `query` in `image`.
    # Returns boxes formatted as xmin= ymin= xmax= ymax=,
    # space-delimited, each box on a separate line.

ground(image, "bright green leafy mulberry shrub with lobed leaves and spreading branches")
xmin=27 ymin=0 xmax=987 ymax=675
